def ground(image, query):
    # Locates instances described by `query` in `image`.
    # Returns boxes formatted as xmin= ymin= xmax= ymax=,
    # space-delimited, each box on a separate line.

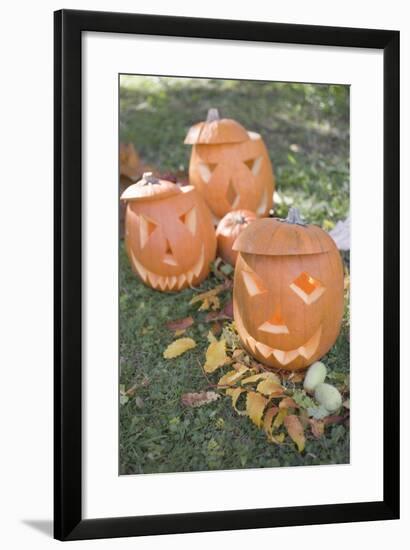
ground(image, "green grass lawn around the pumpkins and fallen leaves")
xmin=120 ymin=77 xmax=349 ymax=474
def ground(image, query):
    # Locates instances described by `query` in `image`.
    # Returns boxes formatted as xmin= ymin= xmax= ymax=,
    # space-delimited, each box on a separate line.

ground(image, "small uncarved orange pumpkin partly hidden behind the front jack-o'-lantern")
xmin=216 ymin=210 xmax=257 ymax=266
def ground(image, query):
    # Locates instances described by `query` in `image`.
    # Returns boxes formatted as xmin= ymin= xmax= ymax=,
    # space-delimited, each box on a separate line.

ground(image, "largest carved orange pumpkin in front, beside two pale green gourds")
xmin=233 ymin=209 xmax=344 ymax=370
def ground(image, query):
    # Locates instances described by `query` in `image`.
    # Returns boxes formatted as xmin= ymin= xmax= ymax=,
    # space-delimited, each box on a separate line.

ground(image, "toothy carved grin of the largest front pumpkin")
xmin=235 ymin=315 xmax=322 ymax=366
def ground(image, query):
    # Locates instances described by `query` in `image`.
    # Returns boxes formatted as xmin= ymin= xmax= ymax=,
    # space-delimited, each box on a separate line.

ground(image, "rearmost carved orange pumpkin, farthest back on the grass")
xmin=185 ymin=109 xmax=275 ymax=223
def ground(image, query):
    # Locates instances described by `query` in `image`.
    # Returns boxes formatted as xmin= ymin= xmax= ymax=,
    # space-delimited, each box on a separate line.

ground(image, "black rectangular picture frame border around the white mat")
xmin=54 ymin=10 xmax=400 ymax=540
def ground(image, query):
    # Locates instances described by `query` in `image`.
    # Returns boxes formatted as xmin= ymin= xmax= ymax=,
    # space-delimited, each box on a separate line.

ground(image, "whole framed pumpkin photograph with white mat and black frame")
xmin=54 ymin=10 xmax=399 ymax=540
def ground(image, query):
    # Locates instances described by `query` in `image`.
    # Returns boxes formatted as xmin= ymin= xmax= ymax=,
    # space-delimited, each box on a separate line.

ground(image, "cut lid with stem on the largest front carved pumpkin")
xmin=232 ymin=208 xmax=335 ymax=256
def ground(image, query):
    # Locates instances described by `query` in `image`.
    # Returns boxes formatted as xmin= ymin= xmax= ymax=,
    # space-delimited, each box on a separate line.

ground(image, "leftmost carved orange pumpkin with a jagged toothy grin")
xmin=121 ymin=173 xmax=216 ymax=291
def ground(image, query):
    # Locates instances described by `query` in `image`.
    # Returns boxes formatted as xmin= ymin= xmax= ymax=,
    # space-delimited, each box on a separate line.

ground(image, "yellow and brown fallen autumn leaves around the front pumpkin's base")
xmin=163 ymin=272 xmax=349 ymax=453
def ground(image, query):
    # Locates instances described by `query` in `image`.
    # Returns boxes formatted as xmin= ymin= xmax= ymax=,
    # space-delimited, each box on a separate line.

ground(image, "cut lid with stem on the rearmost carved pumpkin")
xmin=184 ymin=109 xmax=250 ymax=145
